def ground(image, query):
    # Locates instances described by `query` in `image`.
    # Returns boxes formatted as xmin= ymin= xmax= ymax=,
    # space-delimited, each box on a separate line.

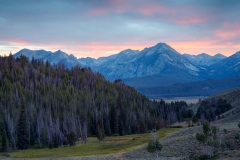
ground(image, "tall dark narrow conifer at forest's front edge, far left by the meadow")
xmin=17 ymin=98 xmax=29 ymax=149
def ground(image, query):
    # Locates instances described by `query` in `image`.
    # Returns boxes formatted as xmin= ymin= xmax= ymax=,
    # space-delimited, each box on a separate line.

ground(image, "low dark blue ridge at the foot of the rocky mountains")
xmin=137 ymin=75 xmax=240 ymax=98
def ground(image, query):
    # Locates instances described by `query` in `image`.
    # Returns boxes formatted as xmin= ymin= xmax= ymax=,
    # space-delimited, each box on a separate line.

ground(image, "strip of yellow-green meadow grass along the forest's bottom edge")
xmin=9 ymin=128 xmax=180 ymax=158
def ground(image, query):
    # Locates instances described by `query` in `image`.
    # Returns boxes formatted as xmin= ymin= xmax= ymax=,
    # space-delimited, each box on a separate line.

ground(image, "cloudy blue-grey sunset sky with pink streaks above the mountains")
xmin=0 ymin=0 xmax=240 ymax=58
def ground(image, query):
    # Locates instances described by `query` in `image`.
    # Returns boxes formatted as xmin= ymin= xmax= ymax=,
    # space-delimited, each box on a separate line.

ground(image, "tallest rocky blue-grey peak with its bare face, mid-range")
xmin=78 ymin=43 xmax=206 ymax=80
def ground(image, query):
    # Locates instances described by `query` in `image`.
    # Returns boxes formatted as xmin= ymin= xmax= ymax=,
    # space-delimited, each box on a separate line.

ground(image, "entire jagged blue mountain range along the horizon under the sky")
xmin=14 ymin=43 xmax=240 ymax=97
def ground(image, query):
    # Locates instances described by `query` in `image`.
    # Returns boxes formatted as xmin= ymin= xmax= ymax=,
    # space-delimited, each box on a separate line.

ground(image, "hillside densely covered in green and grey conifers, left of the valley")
xmin=0 ymin=55 xmax=192 ymax=151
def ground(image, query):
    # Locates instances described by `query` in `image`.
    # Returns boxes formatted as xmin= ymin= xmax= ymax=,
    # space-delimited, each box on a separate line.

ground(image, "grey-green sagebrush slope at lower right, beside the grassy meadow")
xmin=121 ymin=114 xmax=240 ymax=160
